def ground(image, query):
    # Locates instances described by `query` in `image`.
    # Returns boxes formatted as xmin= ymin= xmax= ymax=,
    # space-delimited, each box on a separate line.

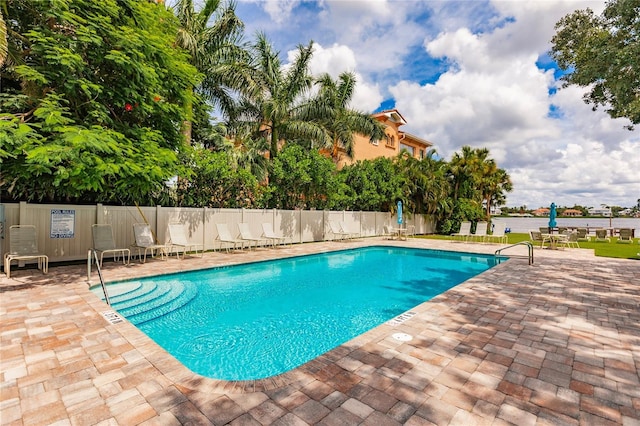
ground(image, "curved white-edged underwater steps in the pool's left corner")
xmin=94 ymin=282 xmax=198 ymax=325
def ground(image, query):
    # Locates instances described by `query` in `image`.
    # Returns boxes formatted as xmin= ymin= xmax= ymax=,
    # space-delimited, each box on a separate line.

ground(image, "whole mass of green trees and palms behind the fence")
xmin=0 ymin=0 xmax=511 ymax=233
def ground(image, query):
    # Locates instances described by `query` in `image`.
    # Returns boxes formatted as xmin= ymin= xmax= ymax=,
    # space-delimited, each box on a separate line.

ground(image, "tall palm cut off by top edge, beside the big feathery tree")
xmin=173 ymin=0 xmax=246 ymax=144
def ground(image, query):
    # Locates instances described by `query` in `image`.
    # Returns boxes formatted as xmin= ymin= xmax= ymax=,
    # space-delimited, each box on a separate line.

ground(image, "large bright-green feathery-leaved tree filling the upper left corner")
xmin=0 ymin=0 xmax=198 ymax=203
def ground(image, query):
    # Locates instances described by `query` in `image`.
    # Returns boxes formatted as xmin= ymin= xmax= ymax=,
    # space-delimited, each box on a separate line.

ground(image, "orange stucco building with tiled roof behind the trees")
xmin=338 ymin=109 xmax=433 ymax=168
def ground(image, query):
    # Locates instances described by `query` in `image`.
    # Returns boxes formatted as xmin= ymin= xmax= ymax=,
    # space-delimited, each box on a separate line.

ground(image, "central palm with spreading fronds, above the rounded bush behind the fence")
xmin=231 ymin=34 xmax=328 ymax=159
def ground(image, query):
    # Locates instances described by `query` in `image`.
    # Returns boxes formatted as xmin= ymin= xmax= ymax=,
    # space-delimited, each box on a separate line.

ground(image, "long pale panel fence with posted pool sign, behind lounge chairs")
xmin=0 ymin=202 xmax=435 ymax=262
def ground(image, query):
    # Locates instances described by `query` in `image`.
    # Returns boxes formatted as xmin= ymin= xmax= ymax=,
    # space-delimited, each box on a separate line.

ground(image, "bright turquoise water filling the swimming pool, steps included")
xmin=93 ymin=247 xmax=498 ymax=380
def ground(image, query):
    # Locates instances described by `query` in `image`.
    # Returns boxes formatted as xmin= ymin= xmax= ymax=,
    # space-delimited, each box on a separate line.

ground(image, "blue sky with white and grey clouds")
xmin=236 ymin=0 xmax=640 ymax=209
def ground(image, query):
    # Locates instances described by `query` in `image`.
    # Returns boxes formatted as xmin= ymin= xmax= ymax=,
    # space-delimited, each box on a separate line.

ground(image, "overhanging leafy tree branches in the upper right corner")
xmin=551 ymin=0 xmax=640 ymax=129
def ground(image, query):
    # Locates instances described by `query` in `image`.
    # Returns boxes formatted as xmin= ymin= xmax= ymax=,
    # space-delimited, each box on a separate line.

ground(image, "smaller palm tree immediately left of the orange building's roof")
xmin=310 ymin=72 xmax=384 ymax=163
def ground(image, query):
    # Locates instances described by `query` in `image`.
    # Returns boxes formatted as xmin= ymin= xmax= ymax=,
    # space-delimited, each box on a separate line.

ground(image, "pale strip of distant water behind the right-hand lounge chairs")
xmin=492 ymin=217 xmax=640 ymax=237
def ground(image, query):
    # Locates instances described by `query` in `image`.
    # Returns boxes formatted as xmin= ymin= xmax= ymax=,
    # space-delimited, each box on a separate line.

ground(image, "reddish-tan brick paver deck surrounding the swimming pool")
xmin=0 ymin=239 xmax=640 ymax=426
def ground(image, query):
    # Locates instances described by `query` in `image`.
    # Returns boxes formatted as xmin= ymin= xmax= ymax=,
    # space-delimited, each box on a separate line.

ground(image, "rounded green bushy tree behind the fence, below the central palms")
xmin=265 ymin=144 xmax=337 ymax=209
